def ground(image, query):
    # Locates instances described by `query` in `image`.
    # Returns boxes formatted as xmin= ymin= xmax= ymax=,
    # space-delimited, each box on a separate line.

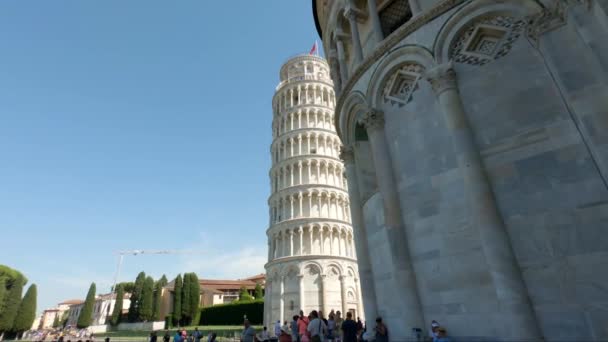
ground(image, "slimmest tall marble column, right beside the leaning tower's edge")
xmin=340 ymin=146 xmax=378 ymax=322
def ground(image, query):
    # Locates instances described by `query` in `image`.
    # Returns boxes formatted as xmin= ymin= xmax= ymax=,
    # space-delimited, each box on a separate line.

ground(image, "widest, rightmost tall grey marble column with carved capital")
xmin=426 ymin=63 xmax=541 ymax=340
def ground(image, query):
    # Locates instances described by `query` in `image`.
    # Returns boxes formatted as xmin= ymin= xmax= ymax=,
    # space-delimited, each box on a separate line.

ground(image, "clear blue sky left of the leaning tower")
xmin=0 ymin=0 xmax=318 ymax=311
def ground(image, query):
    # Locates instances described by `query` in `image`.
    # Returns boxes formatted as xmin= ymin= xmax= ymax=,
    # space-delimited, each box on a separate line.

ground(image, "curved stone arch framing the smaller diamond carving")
xmin=366 ymin=45 xmax=436 ymax=108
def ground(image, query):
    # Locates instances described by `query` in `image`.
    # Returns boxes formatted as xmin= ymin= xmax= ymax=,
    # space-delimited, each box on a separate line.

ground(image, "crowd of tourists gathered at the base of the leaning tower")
xmin=246 ymin=310 xmax=450 ymax=342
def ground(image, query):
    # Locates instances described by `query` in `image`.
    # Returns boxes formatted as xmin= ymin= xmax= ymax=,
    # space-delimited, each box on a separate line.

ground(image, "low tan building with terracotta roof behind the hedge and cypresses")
xmin=161 ymin=273 xmax=266 ymax=317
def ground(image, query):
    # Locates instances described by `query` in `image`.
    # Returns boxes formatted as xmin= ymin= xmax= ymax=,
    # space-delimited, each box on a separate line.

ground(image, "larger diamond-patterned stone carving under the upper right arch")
xmin=450 ymin=15 xmax=527 ymax=65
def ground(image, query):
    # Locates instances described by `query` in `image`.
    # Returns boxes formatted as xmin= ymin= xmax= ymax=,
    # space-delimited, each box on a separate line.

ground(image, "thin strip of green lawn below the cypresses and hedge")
xmin=95 ymin=325 xmax=262 ymax=341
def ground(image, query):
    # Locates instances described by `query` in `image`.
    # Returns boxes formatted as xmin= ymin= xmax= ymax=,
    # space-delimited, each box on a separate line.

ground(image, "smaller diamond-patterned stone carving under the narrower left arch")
xmin=382 ymin=63 xmax=424 ymax=107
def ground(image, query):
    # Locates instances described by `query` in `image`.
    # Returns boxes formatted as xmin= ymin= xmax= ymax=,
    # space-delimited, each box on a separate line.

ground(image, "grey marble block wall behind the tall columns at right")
xmin=330 ymin=0 xmax=608 ymax=340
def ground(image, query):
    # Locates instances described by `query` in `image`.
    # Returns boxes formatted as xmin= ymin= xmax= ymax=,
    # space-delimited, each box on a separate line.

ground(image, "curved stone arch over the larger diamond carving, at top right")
xmin=433 ymin=0 xmax=542 ymax=64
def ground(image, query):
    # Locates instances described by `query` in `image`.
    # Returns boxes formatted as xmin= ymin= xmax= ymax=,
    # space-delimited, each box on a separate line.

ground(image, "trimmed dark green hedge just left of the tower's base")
xmin=199 ymin=299 xmax=264 ymax=325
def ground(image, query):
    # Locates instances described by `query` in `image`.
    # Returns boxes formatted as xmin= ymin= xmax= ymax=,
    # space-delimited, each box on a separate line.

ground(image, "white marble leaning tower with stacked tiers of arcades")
xmin=264 ymin=55 xmax=362 ymax=324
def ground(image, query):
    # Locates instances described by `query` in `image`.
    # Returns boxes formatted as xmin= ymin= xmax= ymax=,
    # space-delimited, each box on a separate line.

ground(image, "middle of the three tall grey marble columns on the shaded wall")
xmin=358 ymin=109 xmax=424 ymax=338
